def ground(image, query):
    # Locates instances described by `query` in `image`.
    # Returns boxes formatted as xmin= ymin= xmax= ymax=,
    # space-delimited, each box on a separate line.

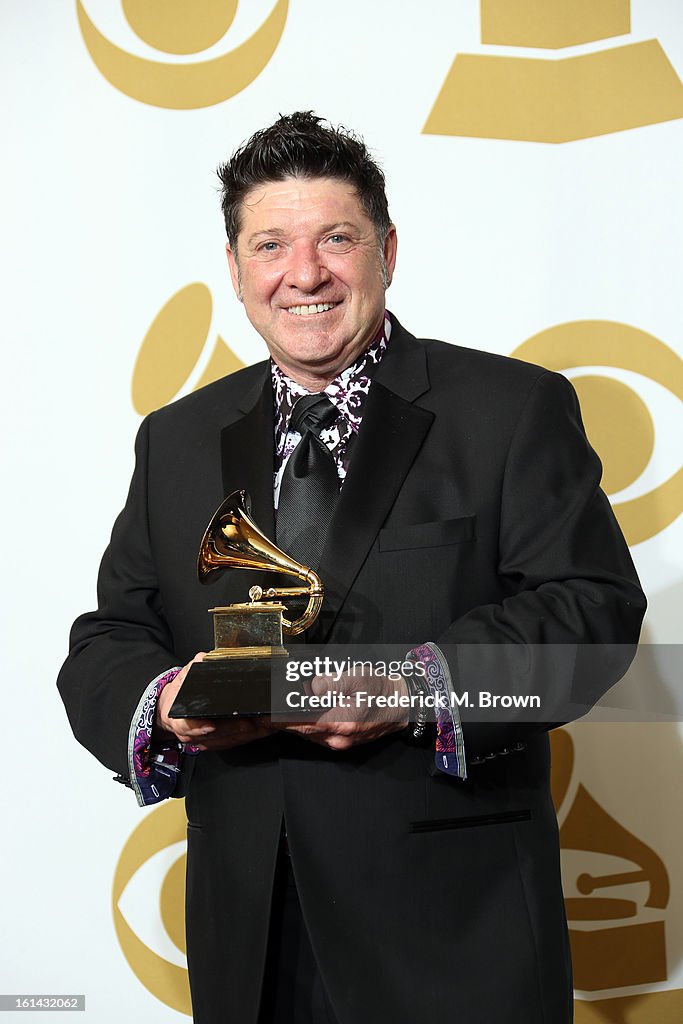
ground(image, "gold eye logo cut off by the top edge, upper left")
xmin=76 ymin=0 xmax=289 ymax=111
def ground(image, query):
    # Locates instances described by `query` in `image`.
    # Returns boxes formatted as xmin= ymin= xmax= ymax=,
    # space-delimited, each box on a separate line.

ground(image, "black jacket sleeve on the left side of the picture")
xmin=57 ymin=420 xmax=177 ymax=778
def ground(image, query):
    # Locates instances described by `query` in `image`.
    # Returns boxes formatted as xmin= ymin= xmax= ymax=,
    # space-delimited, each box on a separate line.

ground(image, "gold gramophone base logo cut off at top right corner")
xmin=423 ymin=0 xmax=683 ymax=142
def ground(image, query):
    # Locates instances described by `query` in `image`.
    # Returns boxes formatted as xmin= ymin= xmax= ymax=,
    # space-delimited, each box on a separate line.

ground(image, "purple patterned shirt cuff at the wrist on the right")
xmin=407 ymin=643 xmax=467 ymax=779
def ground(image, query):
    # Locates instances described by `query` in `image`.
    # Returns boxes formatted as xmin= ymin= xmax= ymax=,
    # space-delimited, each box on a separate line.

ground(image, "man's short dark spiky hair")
xmin=218 ymin=111 xmax=391 ymax=250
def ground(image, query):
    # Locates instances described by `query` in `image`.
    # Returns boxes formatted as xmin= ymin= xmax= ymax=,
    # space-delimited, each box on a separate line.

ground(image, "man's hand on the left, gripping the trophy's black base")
xmin=154 ymin=651 xmax=272 ymax=751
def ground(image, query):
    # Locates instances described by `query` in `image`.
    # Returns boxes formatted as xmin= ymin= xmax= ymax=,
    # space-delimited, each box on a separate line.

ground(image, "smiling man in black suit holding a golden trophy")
xmin=59 ymin=113 xmax=644 ymax=1024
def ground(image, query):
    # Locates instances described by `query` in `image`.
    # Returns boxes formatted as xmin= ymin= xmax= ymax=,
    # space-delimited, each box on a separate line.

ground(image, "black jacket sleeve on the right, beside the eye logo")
xmin=437 ymin=372 xmax=646 ymax=755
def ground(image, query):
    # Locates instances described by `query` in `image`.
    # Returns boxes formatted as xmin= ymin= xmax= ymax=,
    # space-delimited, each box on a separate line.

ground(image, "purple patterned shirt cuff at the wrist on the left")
xmin=128 ymin=667 xmax=199 ymax=807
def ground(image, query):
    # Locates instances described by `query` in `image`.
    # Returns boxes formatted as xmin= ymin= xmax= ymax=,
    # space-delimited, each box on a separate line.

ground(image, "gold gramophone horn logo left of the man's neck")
xmin=131 ymin=282 xmax=244 ymax=416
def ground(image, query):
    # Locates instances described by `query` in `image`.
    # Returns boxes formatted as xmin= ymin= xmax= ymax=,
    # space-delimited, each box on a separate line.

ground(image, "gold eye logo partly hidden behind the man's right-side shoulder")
xmin=510 ymin=321 xmax=683 ymax=545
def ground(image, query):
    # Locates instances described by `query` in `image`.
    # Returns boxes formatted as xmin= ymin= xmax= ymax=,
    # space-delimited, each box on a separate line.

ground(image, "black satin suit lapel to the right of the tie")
xmin=307 ymin=321 xmax=434 ymax=642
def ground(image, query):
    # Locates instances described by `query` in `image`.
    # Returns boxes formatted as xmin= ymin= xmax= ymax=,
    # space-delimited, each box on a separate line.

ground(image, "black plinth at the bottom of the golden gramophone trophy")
xmin=169 ymin=648 xmax=280 ymax=718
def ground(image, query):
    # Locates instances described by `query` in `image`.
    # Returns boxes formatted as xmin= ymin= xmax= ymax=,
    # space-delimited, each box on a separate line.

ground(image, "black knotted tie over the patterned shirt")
xmin=275 ymin=394 xmax=339 ymax=568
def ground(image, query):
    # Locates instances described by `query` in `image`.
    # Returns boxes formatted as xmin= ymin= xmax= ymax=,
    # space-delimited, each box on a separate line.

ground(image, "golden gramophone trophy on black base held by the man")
xmin=170 ymin=490 xmax=324 ymax=718
